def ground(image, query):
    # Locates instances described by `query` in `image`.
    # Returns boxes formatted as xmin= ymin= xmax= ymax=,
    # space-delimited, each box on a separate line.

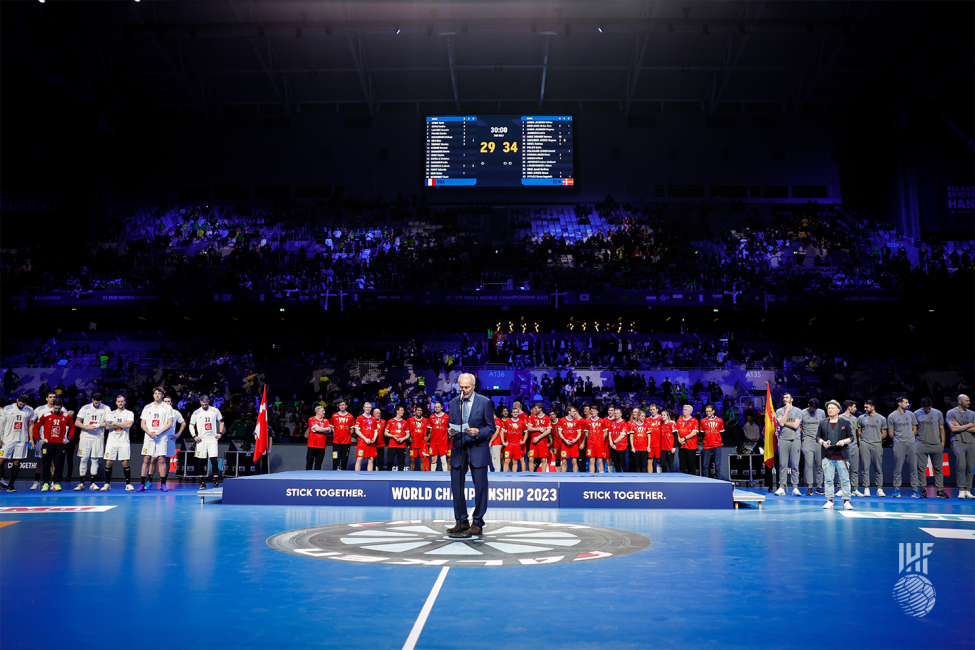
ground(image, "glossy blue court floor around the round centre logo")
xmin=0 ymin=483 xmax=975 ymax=650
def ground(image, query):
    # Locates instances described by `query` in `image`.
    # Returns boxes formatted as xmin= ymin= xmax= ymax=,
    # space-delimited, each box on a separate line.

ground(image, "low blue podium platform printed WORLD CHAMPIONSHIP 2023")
xmin=222 ymin=471 xmax=734 ymax=510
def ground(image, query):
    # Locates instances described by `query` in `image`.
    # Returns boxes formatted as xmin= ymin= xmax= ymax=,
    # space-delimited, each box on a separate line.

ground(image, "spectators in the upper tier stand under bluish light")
xmin=0 ymin=197 xmax=973 ymax=297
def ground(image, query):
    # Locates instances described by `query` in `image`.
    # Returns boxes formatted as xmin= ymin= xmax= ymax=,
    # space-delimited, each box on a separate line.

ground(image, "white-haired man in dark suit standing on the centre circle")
xmin=447 ymin=372 xmax=494 ymax=536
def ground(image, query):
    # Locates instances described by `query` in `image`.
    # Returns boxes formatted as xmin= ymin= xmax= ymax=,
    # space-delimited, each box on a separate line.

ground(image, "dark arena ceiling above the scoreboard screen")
xmin=0 ymin=0 xmax=975 ymax=115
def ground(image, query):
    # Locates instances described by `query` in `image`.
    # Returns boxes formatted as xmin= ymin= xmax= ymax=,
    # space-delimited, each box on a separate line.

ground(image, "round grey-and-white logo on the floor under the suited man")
xmin=267 ymin=519 xmax=650 ymax=567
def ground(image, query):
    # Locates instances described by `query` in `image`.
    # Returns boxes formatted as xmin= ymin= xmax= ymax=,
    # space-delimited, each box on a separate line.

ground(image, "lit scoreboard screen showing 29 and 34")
xmin=424 ymin=115 xmax=573 ymax=188
